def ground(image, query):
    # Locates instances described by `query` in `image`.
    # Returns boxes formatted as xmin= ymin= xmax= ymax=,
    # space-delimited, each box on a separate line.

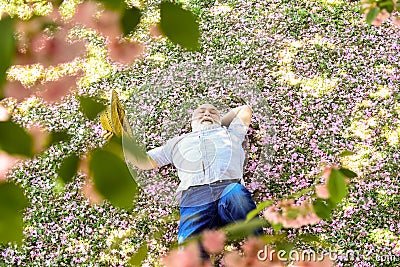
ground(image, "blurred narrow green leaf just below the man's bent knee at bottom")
xmin=223 ymin=218 xmax=267 ymax=240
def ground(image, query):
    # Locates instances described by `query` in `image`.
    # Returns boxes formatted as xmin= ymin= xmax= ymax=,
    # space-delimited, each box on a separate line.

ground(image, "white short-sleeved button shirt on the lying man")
xmin=147 ymin=117 xmax=248 ymax=192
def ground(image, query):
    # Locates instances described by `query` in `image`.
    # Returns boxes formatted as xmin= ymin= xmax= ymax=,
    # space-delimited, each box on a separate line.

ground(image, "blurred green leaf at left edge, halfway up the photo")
xmin=0 ymin=121 xmax=33 ymax=157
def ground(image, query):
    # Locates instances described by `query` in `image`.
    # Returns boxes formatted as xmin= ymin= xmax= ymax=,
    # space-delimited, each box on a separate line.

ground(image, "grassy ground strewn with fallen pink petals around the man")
xmin=0 ymin=0 xmax=400 ymax=266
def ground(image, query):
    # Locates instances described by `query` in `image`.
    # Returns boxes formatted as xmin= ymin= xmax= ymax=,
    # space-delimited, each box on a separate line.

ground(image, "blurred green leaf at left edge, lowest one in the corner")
xmin=0 ymin=183 xmax=28 ymax=244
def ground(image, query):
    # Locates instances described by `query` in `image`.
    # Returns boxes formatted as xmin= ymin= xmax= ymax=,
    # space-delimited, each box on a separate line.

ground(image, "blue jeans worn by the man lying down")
xmin=178 ymin=181 xmax=256 ymax=244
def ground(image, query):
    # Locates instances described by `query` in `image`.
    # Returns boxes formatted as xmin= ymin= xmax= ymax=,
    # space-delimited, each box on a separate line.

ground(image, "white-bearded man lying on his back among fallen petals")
xmin=130 ymin=104 xmax=256 ymax=247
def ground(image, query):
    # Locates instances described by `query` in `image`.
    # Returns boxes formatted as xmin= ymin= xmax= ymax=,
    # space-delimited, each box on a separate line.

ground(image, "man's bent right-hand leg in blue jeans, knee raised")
xmin=218 ymin=183 xmax=263 ymax=235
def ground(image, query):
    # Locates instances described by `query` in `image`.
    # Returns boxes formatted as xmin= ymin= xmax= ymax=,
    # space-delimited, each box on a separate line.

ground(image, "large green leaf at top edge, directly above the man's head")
xmin=160 ymin=1 xmax=200 ymax=50
